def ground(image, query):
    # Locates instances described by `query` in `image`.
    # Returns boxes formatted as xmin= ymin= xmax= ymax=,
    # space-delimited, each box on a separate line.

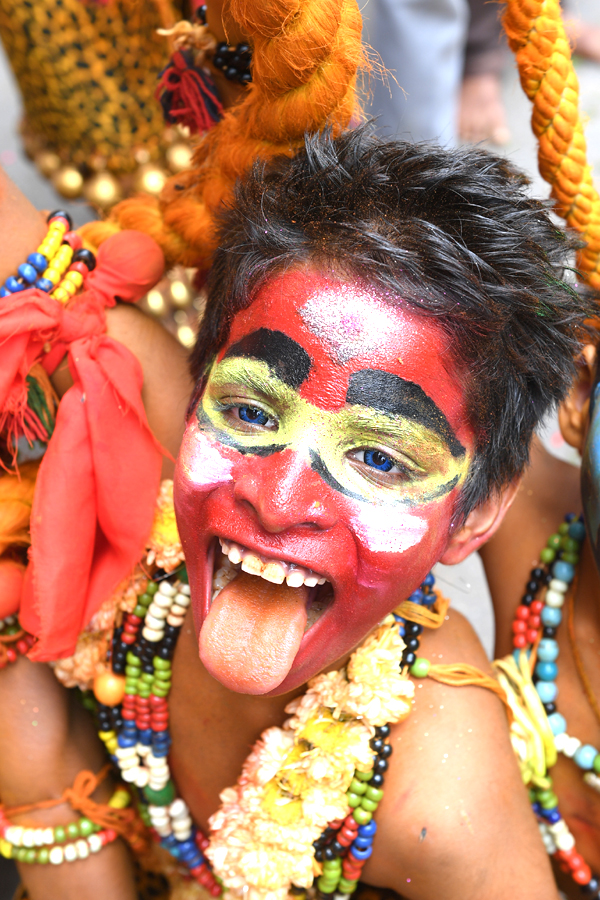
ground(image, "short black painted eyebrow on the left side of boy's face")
xmin=223 ymin=328 xmax=312 ymax=390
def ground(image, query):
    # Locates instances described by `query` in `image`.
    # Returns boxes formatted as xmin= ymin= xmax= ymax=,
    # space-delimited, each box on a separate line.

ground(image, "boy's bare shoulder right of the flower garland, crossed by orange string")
xmin=365 ymin=613 xmax=556 ymax=900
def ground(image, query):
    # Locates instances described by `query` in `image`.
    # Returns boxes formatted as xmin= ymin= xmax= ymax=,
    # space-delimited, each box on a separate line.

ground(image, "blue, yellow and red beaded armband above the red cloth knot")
xmin=0 ymin=210 xmax=96 ymax=303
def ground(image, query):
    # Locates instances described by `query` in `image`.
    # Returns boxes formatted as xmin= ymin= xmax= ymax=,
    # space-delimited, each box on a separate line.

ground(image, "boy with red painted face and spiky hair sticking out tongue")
xmin=163 ymin=130 xmax=582 ymax=900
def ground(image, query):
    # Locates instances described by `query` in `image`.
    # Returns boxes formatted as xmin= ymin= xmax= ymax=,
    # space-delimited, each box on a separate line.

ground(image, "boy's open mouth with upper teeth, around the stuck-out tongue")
xmin=211 ymin=538 xmax=333 ymax=632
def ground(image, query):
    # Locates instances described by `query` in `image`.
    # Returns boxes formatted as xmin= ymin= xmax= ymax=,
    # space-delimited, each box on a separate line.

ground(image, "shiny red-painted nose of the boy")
xmin=233 ymin=450 xmax=338 ymax=534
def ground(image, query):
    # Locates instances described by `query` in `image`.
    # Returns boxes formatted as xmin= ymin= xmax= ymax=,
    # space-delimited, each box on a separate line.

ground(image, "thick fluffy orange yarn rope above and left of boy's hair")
xmin=81 ymin=0 xmax=363 ymax=269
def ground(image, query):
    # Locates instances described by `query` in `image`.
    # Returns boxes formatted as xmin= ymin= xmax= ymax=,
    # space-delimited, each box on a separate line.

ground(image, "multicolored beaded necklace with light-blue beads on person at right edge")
xmin=512 ymin=514 xmax=600 ymax=898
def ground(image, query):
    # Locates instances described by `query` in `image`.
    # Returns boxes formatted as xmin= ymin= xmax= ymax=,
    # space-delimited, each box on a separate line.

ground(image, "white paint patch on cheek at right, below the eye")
xmin=350 ymin=506 xmax=427 ymax=553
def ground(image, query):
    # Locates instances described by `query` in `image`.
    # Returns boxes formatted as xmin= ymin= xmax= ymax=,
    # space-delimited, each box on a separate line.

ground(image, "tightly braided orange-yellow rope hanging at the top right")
xmin=504 ymin=0 xmax=600 ymax=290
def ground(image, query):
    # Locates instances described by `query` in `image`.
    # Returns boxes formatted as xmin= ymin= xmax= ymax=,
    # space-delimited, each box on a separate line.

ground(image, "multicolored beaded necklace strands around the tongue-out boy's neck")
xmin=94 ymin=568 xmax=437 ymax=897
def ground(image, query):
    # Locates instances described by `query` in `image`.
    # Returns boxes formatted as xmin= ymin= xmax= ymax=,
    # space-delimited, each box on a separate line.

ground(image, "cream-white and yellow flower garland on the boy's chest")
xmin=206 ymin=616 xmax=414 ymax=900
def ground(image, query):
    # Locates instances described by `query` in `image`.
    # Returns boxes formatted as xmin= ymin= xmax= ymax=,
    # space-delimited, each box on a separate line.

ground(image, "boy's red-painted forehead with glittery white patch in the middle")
xmin=220 ymin=271 xmax=464 ymax=425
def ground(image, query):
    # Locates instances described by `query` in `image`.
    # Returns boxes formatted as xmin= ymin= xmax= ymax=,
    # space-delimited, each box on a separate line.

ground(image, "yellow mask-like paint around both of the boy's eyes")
xmin=197 ymin=357 xmax=470 ymax=507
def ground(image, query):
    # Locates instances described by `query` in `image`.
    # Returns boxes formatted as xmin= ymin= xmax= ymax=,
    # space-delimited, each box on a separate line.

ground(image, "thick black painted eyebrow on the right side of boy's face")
xmin=346 ymin=369 xmax=466 ymax=458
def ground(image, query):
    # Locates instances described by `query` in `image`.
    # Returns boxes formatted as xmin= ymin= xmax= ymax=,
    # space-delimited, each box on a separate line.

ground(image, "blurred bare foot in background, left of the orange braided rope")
xmin=458 ymin=74 xmax=510 ymax=146
